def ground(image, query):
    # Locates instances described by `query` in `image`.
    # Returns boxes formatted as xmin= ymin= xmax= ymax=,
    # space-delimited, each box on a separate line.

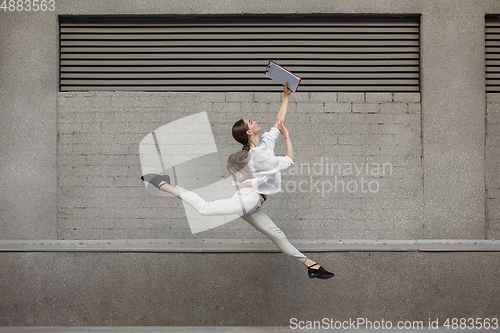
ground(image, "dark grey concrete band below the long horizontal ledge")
xmin=0 ymin=252 xmax=500 ymax=326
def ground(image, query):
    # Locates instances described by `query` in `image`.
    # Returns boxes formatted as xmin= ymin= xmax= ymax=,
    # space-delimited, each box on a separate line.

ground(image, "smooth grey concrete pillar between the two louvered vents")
xmin=421 ymin=12 xmax=486 ymax=239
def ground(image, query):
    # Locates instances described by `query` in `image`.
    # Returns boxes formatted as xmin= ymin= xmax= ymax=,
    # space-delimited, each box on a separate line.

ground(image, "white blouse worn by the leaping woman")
xmin=238 ymin=127 xmax=293 ymax=195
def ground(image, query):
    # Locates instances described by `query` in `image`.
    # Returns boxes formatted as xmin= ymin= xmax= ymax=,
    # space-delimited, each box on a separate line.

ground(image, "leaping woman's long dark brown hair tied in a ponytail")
xmin=227 ymin=119 xmax=252 ymax=179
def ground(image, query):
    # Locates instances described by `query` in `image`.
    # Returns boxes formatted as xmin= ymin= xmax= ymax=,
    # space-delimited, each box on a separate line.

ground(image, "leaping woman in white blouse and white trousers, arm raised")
xmin=141 ymin=85 xmax=334 ymax=279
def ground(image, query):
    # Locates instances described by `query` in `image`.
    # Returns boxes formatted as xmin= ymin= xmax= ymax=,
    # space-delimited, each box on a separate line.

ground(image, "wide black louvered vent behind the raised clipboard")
xmin=60 ymin=15 xmax=420 ymax=92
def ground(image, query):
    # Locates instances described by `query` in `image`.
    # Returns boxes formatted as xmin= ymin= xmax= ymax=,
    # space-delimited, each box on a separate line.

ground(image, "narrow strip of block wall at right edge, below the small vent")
xmin=485 ymin=93 xmax=500 ymax=239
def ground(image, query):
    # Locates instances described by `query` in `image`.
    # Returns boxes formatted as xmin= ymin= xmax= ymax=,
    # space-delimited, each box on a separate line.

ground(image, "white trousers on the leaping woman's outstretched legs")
xmin=173 ymin=186 xmax=306 ymax=263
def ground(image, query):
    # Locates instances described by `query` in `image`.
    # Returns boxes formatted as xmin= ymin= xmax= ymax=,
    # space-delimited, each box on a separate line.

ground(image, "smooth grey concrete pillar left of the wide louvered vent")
xmin=0 ymin=10 xmax=58 ymax=239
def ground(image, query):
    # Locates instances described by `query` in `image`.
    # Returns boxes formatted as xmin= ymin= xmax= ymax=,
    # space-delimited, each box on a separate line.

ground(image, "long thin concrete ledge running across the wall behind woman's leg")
xmin=0 ymin=239 xmax=500 ymax=253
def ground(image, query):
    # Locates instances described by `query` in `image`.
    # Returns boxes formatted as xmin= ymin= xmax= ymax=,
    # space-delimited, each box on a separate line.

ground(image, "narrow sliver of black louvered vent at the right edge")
xmin=485 ymin=15 xmax=500 ymax=92
